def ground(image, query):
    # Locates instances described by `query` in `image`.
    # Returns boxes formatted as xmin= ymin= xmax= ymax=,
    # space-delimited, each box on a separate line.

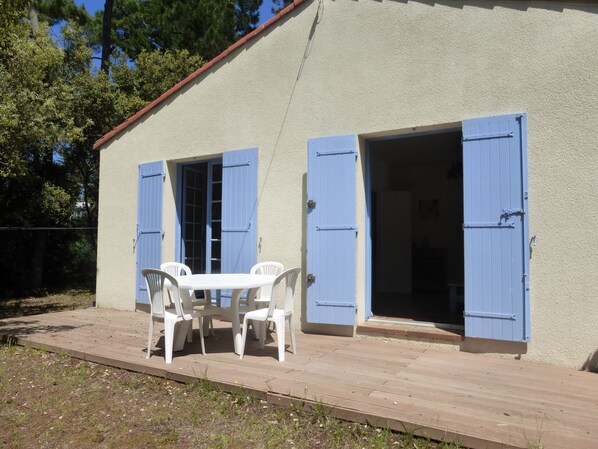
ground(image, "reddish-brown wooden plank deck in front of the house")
xmin=0 ymin=309 xmax=598 ymax=449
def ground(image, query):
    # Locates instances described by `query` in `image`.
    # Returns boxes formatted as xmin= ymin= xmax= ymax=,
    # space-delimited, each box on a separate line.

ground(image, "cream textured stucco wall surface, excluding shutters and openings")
xmin=97 ymin=0 xmax=598 ymax=367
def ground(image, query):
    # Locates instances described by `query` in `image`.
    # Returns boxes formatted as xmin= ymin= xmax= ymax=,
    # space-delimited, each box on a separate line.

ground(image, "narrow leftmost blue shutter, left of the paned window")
xmin=135 ymin=161 xmax=164 ymax=304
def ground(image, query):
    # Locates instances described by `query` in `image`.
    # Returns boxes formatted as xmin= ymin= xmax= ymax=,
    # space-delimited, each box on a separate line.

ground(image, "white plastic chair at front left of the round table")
xmin=141 ymin=268 xmax=211 ymax=363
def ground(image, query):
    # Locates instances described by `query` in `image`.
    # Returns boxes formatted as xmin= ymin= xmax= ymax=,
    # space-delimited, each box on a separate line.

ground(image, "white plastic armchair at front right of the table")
xmin=240 ymin=268 xmax=301 ymax=362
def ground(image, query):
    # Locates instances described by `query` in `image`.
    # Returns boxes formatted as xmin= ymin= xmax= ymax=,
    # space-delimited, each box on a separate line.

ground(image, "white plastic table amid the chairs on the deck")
xmin=176 ymin=273 xmax=276 ymax=354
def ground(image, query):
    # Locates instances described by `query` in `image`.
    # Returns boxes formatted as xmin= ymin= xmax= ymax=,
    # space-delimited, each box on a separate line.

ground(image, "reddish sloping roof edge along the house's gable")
xmin=93 ymin=0 xmax=310 ymax=150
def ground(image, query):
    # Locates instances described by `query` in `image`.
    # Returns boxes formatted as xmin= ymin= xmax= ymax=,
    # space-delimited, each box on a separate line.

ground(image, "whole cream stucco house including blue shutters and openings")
xmin=95 ymin=0 xmax=598 ymax=369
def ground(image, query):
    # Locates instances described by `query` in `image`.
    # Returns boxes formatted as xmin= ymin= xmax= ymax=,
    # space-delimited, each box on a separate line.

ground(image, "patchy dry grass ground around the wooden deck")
xmin=0 ymin=292 xmax=468 ymax=449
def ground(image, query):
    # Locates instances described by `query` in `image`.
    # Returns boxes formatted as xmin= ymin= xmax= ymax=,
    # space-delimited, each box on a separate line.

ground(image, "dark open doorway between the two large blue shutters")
xmin=369 ymin=129 xmax=464 ymax=326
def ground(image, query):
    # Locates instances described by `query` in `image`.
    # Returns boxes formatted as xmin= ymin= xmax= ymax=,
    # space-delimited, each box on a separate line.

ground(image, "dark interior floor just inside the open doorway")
xmin=372 ymin=292 xmax=463 ymax=325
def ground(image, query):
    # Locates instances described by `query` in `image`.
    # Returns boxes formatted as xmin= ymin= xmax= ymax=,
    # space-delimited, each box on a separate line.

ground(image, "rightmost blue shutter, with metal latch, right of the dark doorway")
xmin=463 ymin=114 xmax=530 ymax=341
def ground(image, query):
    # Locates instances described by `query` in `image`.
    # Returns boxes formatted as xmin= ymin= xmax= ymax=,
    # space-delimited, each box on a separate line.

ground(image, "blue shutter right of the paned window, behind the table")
xmin=221 ymin=148 xmax=258 ymax=306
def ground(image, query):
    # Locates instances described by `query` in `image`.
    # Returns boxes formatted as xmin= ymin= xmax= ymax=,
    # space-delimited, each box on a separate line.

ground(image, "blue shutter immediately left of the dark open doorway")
xmin=307 ymin=135 xmax=357 ymax=325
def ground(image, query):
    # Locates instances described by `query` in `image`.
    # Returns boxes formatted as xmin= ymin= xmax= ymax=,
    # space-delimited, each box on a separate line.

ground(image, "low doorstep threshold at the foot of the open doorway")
xmin=355 ymin=316 xmax=464 ymax=344
